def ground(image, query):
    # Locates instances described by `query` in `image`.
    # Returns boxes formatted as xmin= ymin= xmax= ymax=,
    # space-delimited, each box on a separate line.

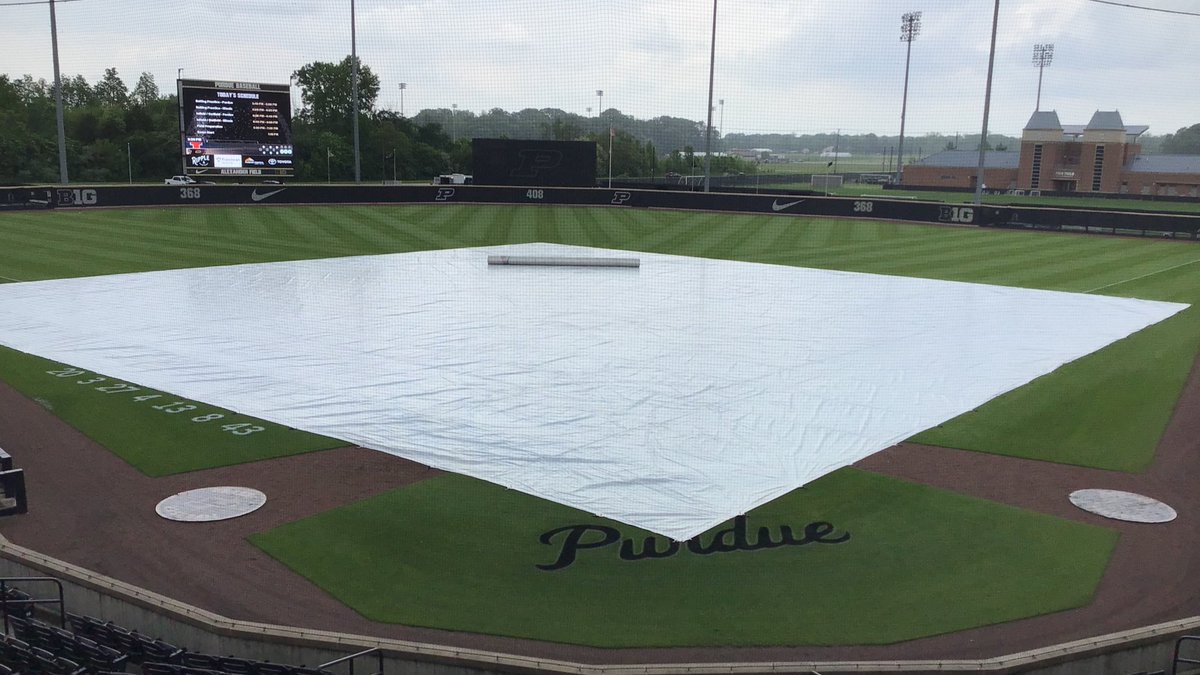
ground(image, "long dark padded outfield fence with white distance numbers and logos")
xmin=0 ymin=184 xmax=1200 ymax=239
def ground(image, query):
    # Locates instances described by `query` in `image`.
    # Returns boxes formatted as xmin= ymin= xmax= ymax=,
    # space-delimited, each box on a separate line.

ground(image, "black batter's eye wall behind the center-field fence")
xmin=470 ymin=138 xmax=596 ymax=187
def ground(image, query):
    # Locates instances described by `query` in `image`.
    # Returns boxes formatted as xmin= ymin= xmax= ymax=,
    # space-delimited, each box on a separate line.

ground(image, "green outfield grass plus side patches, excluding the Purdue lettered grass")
xmin=0 ymin=205 xmax=1200 ymax=474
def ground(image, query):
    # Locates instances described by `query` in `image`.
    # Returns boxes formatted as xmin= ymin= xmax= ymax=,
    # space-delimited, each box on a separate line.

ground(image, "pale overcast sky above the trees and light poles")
xmin=0 ymin=0 xmax=1200 ymax=136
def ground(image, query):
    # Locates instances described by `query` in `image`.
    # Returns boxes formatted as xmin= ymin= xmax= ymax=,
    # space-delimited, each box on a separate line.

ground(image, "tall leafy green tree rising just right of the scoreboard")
xmin=292 ymin=56 xmax=379 ymax=129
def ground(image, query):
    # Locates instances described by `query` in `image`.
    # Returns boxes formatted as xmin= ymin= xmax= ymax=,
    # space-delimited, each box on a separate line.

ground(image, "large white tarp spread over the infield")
xmin=0 ymin=244 xmax=1187 ymax=539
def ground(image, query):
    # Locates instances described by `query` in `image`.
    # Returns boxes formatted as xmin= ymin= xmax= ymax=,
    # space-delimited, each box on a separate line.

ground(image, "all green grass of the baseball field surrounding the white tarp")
xmin=0 ymin=205 xmax=1200 ymax=647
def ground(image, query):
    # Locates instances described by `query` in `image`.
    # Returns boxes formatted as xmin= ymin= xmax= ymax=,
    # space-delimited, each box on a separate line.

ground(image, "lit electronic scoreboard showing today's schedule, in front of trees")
xmin=176 ymin=79 xmax=294 ymax=177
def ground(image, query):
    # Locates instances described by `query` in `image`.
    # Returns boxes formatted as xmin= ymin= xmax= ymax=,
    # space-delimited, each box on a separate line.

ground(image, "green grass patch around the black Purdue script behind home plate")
xmin=251 ymin=470 xmax=1117 ymax=647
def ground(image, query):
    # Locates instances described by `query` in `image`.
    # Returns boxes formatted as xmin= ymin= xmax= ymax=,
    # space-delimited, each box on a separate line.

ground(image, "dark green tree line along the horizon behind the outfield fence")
xmin=7 ymin=56 xmax=1200 ymax=184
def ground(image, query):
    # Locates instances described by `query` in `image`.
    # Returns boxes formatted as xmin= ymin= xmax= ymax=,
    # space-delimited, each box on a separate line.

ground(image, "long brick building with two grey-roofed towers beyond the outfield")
xmin=901 ymin=110 xmax=1200 ymax=197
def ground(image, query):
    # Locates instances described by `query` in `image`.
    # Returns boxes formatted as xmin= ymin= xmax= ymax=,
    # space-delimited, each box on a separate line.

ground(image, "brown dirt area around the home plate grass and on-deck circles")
xmin=0 ymin=348 xmax=1200 ymax=663
